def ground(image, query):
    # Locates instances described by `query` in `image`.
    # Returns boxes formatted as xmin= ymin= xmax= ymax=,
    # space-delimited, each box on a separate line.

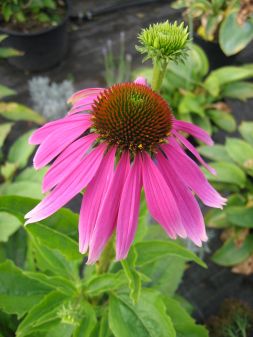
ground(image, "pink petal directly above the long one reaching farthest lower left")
xmin=42 ymin=133 xmax=98 ymax=193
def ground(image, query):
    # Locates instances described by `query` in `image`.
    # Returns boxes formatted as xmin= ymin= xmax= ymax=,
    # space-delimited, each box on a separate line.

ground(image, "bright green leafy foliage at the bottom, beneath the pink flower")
xmin=0 ymin=192 xmax=206 ymax=337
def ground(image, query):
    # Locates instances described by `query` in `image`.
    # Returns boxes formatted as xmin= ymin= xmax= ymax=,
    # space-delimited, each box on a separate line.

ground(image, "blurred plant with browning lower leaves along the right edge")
xmin=199 ymin=122 xmax=253 ymax=275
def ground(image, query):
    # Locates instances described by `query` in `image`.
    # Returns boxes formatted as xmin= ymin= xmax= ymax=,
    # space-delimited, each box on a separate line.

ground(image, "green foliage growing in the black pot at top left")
xmin=0 ymin=0 xmax=63 ymax=25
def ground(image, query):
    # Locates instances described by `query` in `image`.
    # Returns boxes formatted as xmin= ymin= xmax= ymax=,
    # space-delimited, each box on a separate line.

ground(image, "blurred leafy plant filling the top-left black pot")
xmin=0 ymin=0 xmax=66 ymax=30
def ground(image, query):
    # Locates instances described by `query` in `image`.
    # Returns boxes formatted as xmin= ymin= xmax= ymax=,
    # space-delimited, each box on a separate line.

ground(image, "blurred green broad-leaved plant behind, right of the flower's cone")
xmin=134 ymin=44 xmax=253 ymax=134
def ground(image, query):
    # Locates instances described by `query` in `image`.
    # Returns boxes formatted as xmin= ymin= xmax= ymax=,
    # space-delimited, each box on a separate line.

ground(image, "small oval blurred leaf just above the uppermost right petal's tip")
xmin=208 ymin=109 xmax=236 ymax=132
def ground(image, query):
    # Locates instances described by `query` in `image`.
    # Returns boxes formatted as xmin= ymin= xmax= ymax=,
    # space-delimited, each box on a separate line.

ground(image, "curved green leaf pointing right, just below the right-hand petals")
xmin=134 ymin=240 xmax=206 ymax=267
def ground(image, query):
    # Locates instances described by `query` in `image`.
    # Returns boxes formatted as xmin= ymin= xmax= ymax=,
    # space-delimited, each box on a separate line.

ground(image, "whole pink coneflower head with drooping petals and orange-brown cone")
xmin=26 ymin=78 xmax=226 ymax=263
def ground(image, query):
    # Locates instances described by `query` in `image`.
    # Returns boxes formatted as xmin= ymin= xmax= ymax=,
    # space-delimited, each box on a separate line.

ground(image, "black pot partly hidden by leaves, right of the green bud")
xmin=193 ymin=34 xmax=236 ymax=70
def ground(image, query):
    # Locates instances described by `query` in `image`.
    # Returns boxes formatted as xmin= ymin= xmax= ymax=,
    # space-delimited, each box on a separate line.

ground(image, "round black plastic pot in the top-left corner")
xmin=0 ymin=1 xmax=69 ymax=71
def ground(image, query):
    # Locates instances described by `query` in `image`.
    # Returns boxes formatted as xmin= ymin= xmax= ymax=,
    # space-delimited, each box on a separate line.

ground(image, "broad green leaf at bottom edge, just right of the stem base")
xmin=109 ymin=289 xmax=176 ymax=337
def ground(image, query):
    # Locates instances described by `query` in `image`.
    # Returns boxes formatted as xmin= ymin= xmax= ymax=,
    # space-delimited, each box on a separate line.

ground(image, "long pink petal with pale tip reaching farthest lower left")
xmin=25 ymin=144 xmax=106 ymax=223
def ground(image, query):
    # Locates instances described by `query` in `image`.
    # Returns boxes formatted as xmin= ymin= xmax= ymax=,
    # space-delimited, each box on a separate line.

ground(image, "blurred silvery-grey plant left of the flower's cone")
xmin=28 ymin=76 xmax=74 ymax=120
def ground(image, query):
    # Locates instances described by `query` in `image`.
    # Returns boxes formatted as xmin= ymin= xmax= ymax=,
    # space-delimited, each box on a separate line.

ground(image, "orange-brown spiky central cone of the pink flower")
xmin=92 ymin=83 xmax=172 ymax=152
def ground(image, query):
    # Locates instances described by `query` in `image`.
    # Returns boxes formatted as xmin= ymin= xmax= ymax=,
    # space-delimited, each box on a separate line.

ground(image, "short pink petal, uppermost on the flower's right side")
xmin=173 ymin=119 xmax=213 ymax=145
